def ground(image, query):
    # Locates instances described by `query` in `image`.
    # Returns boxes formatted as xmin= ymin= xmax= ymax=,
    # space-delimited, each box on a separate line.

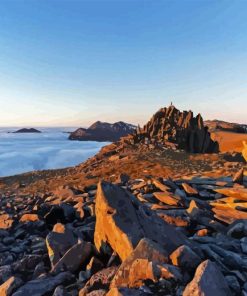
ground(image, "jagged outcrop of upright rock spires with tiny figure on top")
xmin=133 ymin=105 xmax=219 ymax=153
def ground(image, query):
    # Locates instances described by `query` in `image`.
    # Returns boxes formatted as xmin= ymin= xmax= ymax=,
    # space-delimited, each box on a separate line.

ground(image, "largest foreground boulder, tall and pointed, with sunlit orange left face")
xmin=94 ymin=182 xmax=188 ymax=260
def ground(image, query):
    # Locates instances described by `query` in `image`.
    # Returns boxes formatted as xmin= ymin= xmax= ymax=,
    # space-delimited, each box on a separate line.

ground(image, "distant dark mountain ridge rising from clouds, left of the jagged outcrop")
xmin=69 ymin=121 xmax=136 ymax=142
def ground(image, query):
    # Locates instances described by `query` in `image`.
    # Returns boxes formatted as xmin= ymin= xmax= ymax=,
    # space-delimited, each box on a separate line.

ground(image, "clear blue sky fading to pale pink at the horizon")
xmin=0 ymin=0 xmax=247 ymax=126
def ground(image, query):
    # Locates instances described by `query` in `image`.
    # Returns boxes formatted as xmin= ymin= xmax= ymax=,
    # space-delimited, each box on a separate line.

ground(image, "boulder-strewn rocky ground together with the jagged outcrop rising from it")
xmin=0 ymin=106 xmax=247 ymax=296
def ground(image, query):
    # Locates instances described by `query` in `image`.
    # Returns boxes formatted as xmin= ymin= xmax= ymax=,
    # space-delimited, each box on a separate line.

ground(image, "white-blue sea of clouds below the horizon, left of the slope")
xmin=0 ymin=128 xmax=107 ymax=177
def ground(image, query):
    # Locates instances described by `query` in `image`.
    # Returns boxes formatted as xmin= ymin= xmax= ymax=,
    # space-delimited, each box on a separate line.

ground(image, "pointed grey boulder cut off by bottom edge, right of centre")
xmin=183 ymin=260 xmax=232 ymax=296
